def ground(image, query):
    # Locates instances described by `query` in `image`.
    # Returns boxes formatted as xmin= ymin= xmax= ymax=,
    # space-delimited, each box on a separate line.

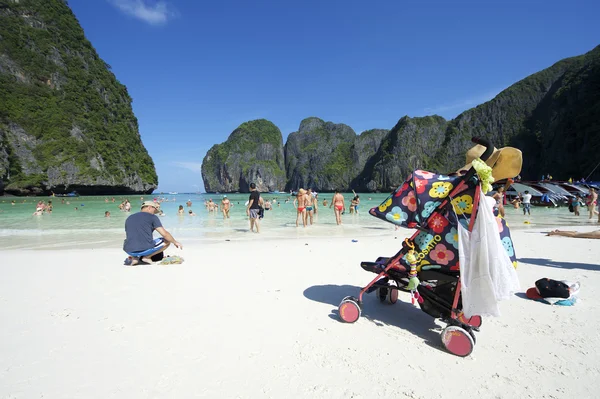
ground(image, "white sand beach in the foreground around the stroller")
xmin=0 ymin=227 xmax=600 ymax=399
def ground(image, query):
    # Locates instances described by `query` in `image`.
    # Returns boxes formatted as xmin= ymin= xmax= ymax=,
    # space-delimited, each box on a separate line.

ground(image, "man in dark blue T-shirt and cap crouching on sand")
xmin=123 ymin=201 xmax=183 ymax=266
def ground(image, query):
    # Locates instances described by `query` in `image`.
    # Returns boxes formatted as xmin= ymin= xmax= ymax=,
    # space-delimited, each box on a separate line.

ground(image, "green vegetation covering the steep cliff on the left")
xmin=0 ymin=0 xmax=158 ymax=194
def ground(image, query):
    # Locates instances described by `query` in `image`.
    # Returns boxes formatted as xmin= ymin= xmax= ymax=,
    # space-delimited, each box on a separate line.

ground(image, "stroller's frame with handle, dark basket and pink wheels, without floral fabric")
xmin=338 ymin=137 xmax=494 ymax=357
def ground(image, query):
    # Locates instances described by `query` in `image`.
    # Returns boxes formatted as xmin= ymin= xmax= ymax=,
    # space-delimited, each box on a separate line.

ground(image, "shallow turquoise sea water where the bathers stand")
xmin=0 ymin=193 xmax=596 ymax=249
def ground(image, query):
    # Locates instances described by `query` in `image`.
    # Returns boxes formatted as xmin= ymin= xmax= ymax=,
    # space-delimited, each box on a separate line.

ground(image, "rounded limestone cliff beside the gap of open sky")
xmin=202 ymin=119 xmax=285 ymax=193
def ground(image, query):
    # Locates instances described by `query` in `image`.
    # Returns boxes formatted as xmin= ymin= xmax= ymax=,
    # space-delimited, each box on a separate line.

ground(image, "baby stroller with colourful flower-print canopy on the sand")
xmin=338 ymin=138 xmax=516 ymax=356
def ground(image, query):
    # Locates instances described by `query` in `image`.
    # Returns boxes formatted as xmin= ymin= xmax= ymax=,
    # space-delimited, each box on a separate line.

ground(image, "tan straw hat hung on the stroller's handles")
xmin=457 ymin=144 xmax=523 ymax=181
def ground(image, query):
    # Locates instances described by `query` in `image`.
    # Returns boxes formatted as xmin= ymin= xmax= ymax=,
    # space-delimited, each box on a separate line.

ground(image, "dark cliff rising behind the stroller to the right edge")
xmin=437 ymin=46 xmax=600 ymax=180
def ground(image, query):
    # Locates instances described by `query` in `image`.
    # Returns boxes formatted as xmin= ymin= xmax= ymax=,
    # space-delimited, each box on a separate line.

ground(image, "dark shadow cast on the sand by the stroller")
xmin=304 ymin=284 xmax=445 ymax=352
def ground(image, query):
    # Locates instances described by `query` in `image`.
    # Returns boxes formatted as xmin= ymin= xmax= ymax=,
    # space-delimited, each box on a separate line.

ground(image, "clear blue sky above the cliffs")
xmin=69 ymin=0 xmax=600 ymax=192
